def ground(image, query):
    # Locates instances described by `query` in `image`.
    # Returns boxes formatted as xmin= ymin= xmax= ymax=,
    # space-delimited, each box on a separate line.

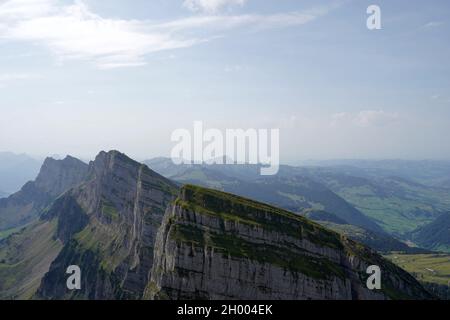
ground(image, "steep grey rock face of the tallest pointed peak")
xmin=37 ymin=151 xmax=177 ymax=299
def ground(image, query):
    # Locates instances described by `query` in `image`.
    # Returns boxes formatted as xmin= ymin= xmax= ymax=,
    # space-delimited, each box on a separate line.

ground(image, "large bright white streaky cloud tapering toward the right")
xmin=0 ymin=0 xmax=336 ymax=68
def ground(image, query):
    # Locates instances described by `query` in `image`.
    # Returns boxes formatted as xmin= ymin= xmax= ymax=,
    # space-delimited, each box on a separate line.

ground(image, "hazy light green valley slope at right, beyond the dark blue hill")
xmin=306 ymin=171 xmax=450 ymax=236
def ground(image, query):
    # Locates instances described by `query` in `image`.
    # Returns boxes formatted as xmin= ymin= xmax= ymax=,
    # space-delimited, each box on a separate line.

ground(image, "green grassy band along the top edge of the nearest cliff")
xmin=176 ymin=185 xmax=343 ymax=249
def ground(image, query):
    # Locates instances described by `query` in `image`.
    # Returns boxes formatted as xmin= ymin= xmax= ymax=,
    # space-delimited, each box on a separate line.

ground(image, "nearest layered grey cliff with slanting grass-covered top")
xmin=145 ymin=186 xmax=430 ymax=299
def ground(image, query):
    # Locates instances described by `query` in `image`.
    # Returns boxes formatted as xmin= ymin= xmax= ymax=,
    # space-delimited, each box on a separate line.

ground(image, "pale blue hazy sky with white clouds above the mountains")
xmin=0 ymin=0 xmax=450 ymax=163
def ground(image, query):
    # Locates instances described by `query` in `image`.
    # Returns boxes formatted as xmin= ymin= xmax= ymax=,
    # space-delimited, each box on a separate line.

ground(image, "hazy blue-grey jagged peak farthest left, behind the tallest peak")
xmin=0 ymin=156 xmax=88 ymax=231
